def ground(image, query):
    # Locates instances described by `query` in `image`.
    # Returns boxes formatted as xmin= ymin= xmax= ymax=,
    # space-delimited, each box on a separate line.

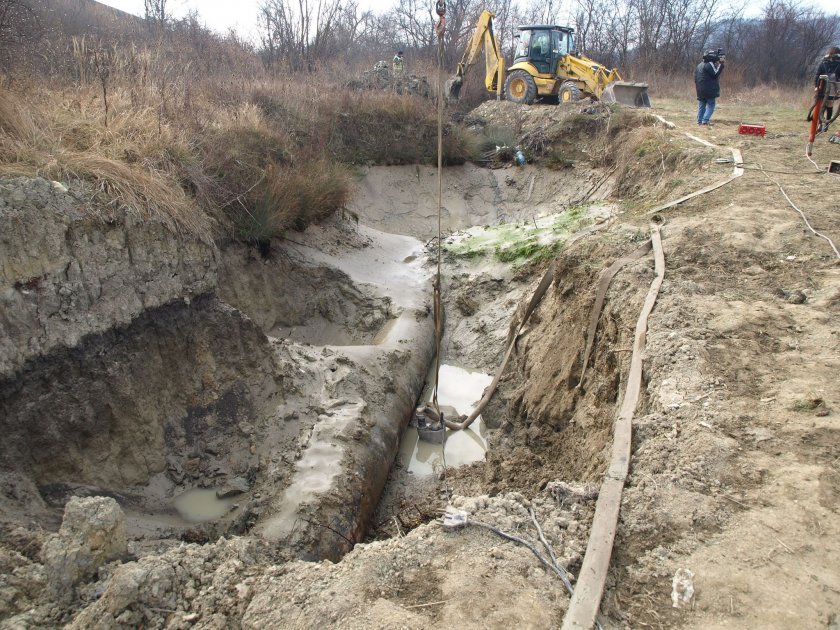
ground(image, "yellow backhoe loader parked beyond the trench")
xmin=446 ymin=11 xmax=650 ymax=107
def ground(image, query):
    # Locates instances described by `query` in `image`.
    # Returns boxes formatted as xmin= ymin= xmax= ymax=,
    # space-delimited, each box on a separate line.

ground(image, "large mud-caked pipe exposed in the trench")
xmin=255 ymin=300 xmax=434 ymax=561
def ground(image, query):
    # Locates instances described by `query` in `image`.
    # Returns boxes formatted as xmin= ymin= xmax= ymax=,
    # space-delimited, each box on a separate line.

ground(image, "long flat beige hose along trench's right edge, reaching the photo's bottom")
xmin=563 ymin=224 xmax=665 ymax=630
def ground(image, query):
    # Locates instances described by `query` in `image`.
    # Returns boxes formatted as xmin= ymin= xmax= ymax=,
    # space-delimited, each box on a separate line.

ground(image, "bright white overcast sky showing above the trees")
xmin=99 ymin=0 xmax=839 ymax=41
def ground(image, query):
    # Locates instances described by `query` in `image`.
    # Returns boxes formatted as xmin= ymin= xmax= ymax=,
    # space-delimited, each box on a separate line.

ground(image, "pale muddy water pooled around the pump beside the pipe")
xmin=399 ymin=365 xmax=493 ymax=475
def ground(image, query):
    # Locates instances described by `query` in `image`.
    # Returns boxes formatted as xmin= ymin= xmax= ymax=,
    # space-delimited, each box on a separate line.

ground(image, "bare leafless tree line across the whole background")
xmin=0 ymin=0 xmax=840 ymax=85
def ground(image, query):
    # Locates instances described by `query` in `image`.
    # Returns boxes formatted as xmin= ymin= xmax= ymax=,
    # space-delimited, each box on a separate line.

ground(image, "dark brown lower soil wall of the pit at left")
xmin=0 ymin=297 xmax=277 ymax=489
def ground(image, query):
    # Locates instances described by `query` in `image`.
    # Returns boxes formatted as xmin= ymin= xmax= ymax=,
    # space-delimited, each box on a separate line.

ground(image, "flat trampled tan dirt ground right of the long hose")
xmin=608 ymin=100 xmax=840 ymax=628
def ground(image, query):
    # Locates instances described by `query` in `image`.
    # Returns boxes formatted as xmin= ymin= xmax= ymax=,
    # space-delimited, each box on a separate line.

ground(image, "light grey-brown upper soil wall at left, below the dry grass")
xmin=0 ymin=178 xmax=216 ymax=377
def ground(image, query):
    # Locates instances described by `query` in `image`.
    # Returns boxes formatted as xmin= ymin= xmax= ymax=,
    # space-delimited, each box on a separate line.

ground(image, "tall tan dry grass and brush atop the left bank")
xmin=0 ymin=70 xmax=442 ymax=242
